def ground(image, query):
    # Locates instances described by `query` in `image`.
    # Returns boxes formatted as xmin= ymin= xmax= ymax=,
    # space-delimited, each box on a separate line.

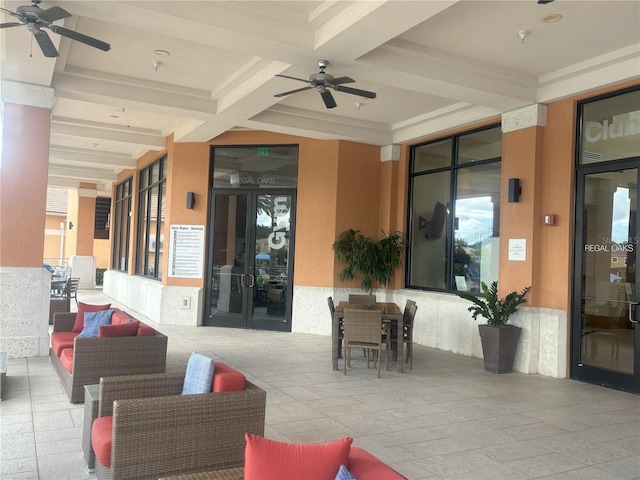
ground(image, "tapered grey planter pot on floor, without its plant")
xmin=478 ymin=325 xmax=521 ymax=373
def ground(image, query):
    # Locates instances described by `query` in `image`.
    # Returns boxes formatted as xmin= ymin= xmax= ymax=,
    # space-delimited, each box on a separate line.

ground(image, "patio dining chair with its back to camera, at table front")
xmin=342 ymin=308 xmax=390 ymax=378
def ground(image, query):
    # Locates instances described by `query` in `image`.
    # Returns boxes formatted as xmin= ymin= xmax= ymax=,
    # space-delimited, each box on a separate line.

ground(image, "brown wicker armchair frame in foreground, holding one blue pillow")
xmin=96 ymin=373 xmax=267 ymax=480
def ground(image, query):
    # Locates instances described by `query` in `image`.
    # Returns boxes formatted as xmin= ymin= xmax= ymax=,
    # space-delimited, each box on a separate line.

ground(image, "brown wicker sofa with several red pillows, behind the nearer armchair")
xmin=49 ymin=309 xmax=167 ymax=403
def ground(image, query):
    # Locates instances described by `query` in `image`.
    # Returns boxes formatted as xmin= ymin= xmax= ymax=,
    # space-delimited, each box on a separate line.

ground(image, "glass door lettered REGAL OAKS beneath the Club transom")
xmin=572 ymin=162 xmax=640 ymax=393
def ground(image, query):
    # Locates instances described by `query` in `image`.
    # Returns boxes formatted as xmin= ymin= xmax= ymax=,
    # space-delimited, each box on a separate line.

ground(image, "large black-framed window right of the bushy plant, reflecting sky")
xmin=407 ymin=126 xmax=502 ymax=291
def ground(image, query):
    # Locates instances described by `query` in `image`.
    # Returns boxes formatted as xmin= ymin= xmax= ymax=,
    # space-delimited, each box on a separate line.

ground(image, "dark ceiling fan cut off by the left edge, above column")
xmin=0 ymin=0 xmax=111 ymax=57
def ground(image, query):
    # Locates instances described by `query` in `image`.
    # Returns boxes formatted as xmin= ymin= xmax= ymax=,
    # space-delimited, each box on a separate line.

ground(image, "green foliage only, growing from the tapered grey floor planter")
xmin=457 ymin=282 xmax=531 ymax=327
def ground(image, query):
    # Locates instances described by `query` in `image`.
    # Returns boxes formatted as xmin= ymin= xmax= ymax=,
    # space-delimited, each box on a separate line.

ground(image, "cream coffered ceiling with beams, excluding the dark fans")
xmin=0 ymin=0 xmax=640 ymax=191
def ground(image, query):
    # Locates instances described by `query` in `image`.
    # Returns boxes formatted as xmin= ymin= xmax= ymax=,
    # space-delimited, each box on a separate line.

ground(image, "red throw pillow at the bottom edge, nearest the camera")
xmin=244 ymin=432 xmax=352 ymax=480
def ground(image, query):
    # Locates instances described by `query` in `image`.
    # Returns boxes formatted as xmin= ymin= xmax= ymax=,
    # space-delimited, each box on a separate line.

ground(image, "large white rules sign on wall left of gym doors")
xmin=169 ymin=225 xmax=204 ymax=278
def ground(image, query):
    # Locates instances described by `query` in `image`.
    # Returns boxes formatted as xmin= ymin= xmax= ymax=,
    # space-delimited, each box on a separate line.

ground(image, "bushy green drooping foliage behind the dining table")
xmin=333 ymin=229 xmax=407 ymax=294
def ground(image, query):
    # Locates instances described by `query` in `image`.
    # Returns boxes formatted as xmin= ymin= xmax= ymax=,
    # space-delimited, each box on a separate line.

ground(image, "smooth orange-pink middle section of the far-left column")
xmin=0 ymin=103 xmax=51 ymax=267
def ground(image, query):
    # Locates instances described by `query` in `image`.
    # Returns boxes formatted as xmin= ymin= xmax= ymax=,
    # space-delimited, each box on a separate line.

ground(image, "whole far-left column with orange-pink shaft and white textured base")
xmin=0 ymin=81 xmax=54 ymax=358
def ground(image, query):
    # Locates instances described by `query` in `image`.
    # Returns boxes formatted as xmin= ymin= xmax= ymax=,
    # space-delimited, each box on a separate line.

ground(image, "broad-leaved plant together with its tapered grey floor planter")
xmin=457 ymin=281 xmax=531 ymax=373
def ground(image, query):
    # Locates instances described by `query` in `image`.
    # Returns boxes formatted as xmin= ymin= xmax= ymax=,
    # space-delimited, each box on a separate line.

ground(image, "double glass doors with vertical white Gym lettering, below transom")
xmin=204 ymin=190 xmax=295 ymax=331
